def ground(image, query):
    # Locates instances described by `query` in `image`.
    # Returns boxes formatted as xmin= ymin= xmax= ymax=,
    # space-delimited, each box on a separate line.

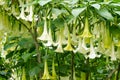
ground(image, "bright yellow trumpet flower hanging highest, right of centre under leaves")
xmin=81 ymin=17 xmax=92 ymax=38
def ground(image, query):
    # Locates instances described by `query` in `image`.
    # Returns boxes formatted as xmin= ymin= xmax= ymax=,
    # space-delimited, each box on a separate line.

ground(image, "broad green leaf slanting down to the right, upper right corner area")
xmin=97 ymin=8 xmax=113 ymax=20
